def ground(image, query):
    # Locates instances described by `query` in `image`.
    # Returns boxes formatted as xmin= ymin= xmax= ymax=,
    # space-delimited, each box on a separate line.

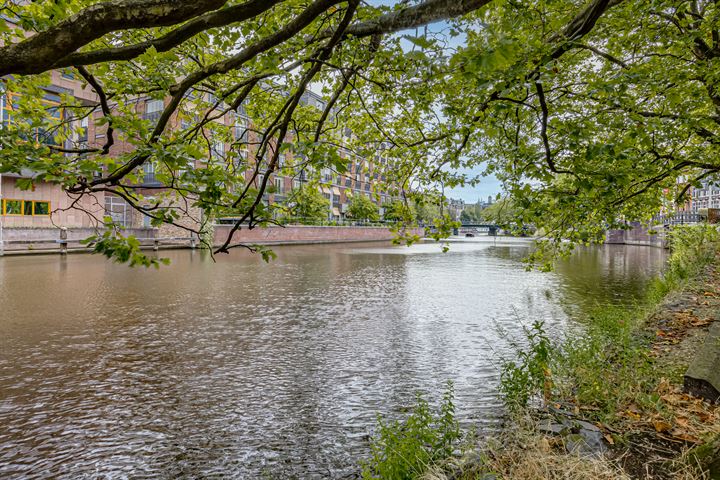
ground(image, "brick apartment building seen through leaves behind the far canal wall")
xmin=0 ymin=66 xmax=392 ymax=244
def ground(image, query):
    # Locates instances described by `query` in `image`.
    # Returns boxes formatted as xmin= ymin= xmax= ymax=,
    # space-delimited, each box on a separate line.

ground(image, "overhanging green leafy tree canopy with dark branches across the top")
xmin=0 ymin=0 xmax=720 ymax=266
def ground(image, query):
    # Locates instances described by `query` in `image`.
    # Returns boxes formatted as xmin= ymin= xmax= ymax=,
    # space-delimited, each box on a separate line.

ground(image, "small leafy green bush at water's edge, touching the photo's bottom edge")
xmin=362 ymin=383 xmax=461 ymax=480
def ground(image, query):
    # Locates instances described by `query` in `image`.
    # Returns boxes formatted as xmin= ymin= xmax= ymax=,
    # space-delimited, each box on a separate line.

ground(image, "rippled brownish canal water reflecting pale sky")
xmin=0 ymin=238 xmax=665 ymax=479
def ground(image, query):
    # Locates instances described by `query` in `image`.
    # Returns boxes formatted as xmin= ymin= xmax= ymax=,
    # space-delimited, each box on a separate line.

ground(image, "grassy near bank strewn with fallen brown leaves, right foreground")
xmin=363 ymin=226 xmax=720 ymax=480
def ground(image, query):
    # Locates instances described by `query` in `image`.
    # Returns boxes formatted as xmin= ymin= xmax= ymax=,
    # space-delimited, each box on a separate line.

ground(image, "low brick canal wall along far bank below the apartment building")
xmin=0 ymin=225 xmax=423 ymax=255
